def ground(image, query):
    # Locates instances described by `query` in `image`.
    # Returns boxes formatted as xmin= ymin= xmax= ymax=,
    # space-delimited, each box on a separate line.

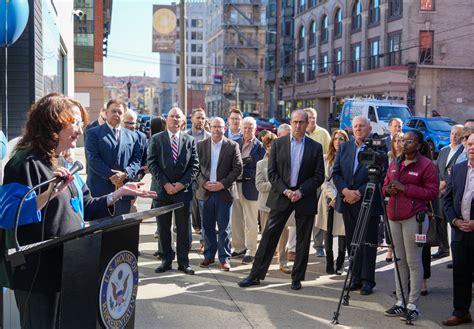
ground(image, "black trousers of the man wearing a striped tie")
xmin=154 ymin=200 xmax=191 ymax=266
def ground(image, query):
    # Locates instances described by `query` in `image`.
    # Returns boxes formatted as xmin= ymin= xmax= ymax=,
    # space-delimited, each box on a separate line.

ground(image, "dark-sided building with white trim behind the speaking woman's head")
xmin=0 ymin=0 xmax=74 ymax=139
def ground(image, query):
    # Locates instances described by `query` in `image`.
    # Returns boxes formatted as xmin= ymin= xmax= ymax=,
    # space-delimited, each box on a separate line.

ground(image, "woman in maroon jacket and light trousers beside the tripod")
xmin=382 ymin=131 xmax=438 ymax=321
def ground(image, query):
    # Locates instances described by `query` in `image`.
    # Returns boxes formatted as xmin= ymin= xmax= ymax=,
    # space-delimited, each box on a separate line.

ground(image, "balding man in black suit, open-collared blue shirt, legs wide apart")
xmin=239 ymin=110 xmax=324 ymax=290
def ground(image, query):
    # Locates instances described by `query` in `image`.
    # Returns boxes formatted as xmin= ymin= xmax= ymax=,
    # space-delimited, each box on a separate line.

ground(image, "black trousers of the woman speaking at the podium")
xmin=15 ymin=290 xmax=60 ymax=329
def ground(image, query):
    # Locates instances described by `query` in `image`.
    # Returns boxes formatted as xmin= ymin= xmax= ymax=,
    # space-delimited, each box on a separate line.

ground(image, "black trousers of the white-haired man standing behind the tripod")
xmin=342 ymin=203 xmax=380 ymax=287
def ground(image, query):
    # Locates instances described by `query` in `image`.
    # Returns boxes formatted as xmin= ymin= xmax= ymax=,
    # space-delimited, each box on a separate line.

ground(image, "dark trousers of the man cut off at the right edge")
xmin=451 ymin=232 xmax=474 ymax=317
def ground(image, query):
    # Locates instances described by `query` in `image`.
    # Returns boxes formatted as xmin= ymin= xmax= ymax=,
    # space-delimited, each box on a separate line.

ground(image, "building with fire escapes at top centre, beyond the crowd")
xmin=206 ymin=0 xmax=267 ymax=116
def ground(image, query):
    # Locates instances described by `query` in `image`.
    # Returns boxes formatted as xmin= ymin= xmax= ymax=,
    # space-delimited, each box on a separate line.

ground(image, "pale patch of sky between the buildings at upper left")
xmin=104 ymin=0 xmax=171 ymax=77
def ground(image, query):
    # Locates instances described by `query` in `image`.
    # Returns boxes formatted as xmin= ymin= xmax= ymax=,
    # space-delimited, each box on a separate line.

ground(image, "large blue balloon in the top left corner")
xmin=0 ymin=0 xmax=30 ymax=47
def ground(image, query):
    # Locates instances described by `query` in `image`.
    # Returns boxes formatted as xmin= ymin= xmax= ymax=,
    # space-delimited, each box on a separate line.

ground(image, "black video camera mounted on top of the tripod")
xmin=357 ymin=134 xmax=387 ymax=178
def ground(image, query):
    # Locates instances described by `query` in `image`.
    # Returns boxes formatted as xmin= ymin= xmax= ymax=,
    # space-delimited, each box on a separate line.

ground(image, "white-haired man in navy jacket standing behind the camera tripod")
xmin=332 ymin=116 xmax=387 ymax=295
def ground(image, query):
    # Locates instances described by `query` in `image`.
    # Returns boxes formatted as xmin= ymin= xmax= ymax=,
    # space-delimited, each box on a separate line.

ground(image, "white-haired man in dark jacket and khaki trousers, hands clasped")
xmin=232 ymin=117 xmax=266 ymax=264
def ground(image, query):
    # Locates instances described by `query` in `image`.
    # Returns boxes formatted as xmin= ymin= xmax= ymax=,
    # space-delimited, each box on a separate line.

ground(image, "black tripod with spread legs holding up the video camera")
xmin=331 ymin=166 xmax=412 ymax=325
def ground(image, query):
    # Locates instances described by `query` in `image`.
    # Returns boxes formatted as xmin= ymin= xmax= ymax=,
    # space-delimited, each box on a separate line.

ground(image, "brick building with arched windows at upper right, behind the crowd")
xmin=280 ymin=0 xmax=474 ymax=126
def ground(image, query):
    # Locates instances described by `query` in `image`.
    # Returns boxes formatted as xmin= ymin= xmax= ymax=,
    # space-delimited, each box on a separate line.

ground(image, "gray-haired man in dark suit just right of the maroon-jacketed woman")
xmin=432 ymin=125 xmax=464 ymax=259
